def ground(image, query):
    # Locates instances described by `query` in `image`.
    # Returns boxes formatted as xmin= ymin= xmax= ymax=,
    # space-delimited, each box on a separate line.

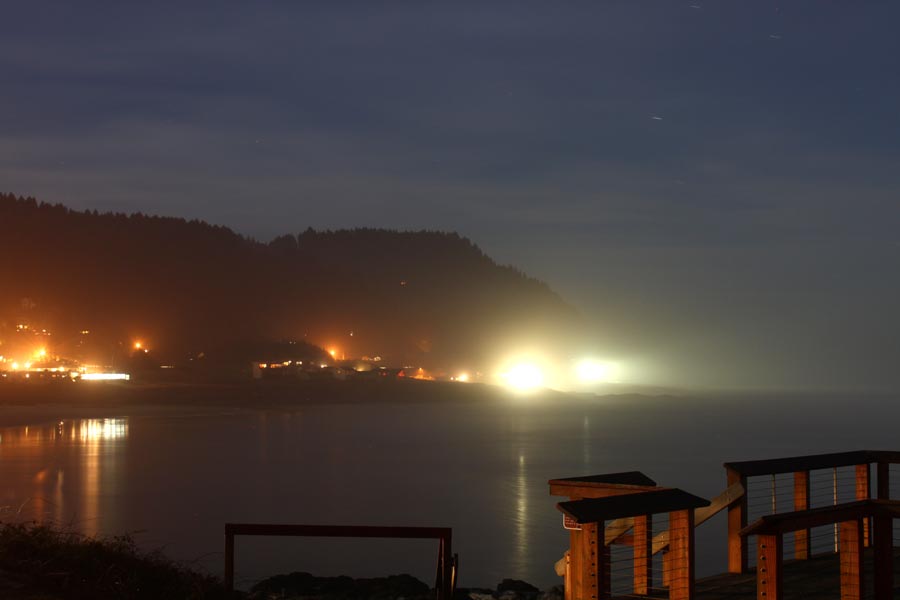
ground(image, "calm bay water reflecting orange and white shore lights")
xmin=0 ymin=395 xmax=900 ymax=587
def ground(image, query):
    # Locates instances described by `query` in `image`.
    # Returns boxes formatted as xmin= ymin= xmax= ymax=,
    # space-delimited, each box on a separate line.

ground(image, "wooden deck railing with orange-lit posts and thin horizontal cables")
xmin=550 ymin=451 xmax=900 ymax=600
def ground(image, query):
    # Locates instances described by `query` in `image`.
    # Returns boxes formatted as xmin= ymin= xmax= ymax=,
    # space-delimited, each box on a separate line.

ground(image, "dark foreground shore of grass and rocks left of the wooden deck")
xmin=0 ymin=522 xmax=563 ymax=600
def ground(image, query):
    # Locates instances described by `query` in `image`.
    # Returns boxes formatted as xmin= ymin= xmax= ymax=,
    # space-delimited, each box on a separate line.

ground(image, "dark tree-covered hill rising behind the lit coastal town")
xmin=0 ymin=195 xmax=575 ymax=367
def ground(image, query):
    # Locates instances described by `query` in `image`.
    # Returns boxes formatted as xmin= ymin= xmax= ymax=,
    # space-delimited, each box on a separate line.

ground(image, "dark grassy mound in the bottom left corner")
xmin=0 ymin=523 xmax=240 ymax=600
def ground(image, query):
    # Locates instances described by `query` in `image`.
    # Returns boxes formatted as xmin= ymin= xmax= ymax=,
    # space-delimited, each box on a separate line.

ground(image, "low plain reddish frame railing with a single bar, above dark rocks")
xmin=225 ymin=523 xmax=459 ymax=600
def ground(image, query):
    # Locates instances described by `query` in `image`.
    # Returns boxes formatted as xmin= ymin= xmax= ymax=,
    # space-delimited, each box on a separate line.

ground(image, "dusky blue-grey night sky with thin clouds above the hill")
xmin=0 ymin=0 xmax=900 ymax=390
